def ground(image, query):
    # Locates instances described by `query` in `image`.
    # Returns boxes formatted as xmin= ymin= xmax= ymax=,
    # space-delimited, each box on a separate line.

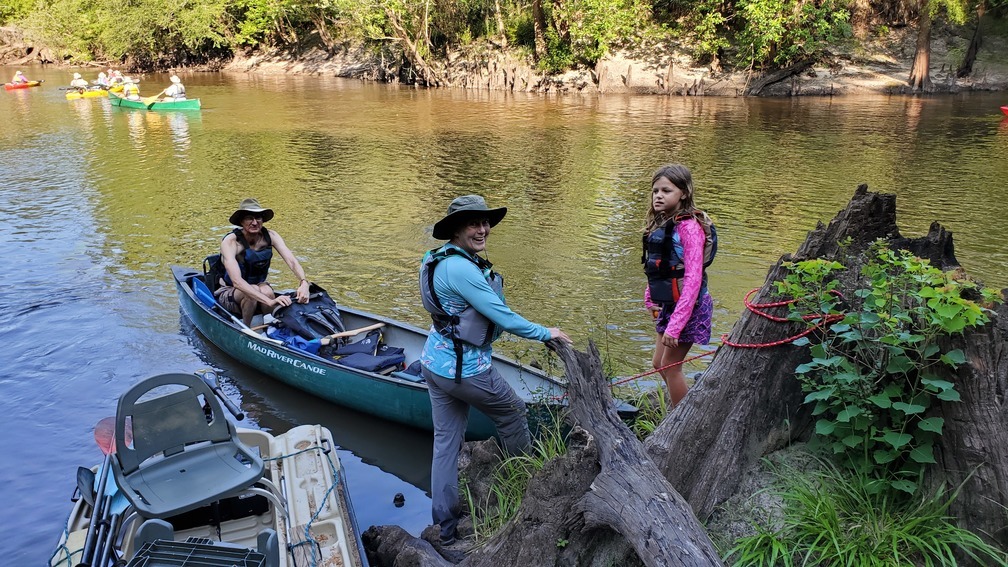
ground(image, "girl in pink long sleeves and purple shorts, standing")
xmin=641 ymin=163 xmax=717 ymax=407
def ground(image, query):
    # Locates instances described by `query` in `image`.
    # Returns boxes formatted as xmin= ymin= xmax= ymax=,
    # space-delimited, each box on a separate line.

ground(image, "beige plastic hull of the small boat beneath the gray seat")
xmin=49 ymin=425 xmax=367 ymax=567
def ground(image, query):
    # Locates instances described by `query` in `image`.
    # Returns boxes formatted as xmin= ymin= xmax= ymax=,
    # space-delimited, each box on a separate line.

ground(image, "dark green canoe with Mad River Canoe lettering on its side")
xmin=171 ymin=265 xmax=636 ymax=439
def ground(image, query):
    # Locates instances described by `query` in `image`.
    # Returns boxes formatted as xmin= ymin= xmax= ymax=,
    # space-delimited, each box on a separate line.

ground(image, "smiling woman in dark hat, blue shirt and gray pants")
xmin=419 ymin=195 xmax=571 ymax=545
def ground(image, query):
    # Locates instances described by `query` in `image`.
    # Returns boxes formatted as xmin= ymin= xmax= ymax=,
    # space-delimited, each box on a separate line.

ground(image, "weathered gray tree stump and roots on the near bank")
xmin=364 ymin=185 xmax=1008 ymax=567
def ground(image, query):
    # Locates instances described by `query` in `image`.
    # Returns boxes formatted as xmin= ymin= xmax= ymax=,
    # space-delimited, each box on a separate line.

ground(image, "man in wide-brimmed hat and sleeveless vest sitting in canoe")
xmin=214 ymin=199 xmax=308 ymax=325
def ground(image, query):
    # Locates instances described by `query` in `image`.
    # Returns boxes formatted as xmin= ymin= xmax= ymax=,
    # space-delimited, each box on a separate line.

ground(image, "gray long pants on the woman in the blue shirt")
xmin=420 ymin=361 xmax=531 ymax=539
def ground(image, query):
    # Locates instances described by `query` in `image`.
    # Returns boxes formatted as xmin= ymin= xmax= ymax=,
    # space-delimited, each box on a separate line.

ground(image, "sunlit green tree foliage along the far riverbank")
xmin=0 ymin=0 xmax=1008 ymax=72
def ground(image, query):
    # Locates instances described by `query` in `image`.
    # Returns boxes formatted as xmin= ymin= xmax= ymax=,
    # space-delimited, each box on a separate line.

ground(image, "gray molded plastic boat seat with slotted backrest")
xmin=111 ymin=373 xmax=265 ymax=519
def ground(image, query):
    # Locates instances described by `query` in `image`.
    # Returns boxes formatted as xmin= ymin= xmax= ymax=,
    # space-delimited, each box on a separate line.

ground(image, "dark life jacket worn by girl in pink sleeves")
xmin=640 ymin=213 xmax=718 ymax=305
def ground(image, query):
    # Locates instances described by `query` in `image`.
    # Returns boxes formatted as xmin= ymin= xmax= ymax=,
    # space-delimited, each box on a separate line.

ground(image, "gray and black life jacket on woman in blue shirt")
xmin=420 ymin=246 xmax=504 ymax=382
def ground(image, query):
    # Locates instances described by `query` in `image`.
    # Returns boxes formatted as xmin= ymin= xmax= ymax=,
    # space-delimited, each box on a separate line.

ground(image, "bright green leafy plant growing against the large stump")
xmin=777 ymin=241 xmax=1000 ymax=494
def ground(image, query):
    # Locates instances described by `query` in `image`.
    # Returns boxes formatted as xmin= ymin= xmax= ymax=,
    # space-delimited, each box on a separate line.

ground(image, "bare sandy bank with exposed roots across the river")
xmin=225 ymin=25 xmax=1008 ymax=96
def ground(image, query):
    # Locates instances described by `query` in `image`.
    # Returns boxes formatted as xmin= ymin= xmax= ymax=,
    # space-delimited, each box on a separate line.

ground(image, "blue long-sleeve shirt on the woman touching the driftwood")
xmin=420 ymin=243 xmax=549 ymax=378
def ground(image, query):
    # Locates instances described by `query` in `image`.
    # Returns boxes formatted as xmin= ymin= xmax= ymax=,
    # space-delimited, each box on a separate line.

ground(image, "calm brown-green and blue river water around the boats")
xmin=0 ymin=68 xmax=1008 ymax=565
